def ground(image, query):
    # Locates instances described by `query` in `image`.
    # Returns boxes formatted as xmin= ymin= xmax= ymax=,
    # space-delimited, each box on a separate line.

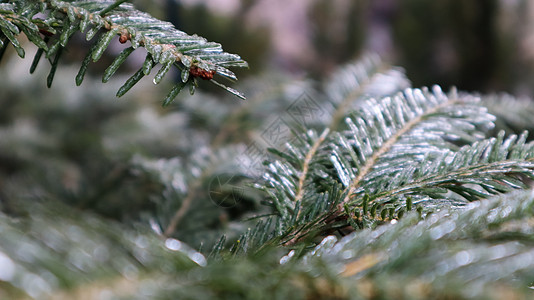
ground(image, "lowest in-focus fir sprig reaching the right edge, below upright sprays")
xmin=360 ymin=132 xmax=534 ymax=201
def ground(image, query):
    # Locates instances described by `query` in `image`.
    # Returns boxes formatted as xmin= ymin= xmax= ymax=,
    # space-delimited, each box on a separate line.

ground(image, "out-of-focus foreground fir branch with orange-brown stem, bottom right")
xmin=304 ymin=190 xmax=534 ymax=299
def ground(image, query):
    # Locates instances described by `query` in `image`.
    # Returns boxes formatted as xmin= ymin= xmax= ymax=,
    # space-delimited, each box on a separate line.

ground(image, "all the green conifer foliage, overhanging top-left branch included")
xmin=0 ymin=1 xmax=534 ymax=299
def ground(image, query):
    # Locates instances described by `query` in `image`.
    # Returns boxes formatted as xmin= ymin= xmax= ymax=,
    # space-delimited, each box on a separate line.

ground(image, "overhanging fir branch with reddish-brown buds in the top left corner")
xmin=0 ymin=0 xmax=247 ymax=105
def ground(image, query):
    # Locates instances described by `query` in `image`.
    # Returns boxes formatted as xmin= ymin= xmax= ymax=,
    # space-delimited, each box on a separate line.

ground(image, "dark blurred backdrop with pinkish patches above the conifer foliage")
xmin=153 ymin=0 xmax=534 ymax=95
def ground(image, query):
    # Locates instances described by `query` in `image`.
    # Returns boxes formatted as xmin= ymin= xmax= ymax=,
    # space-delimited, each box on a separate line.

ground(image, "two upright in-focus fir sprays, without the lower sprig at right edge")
xmin=255 ymin=79 xmax=494 ymax=245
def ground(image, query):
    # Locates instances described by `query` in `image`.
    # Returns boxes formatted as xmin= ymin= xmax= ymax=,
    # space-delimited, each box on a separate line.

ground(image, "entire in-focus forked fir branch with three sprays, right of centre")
xmin=255 ymin=65 xmax=534 ymax=245
